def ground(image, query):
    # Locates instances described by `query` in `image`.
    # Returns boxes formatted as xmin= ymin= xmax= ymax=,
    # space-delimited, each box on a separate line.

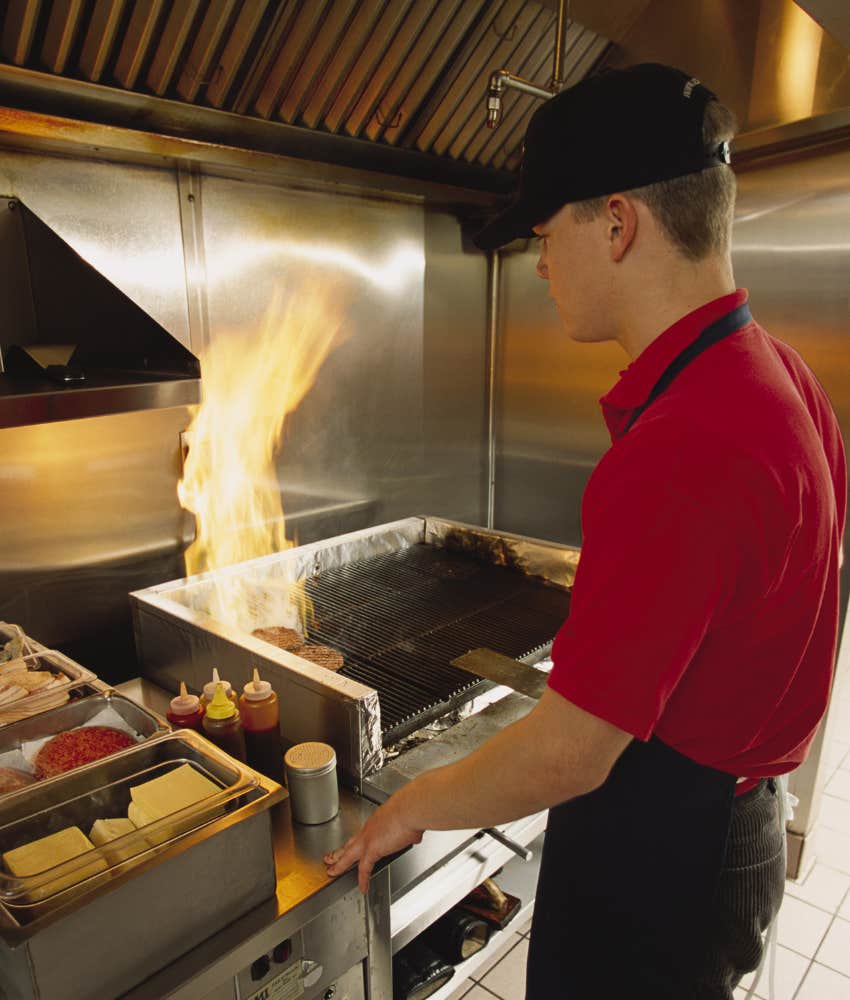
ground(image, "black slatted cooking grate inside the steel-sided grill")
xmin=307 ymin=544 xmax=570 ymax=746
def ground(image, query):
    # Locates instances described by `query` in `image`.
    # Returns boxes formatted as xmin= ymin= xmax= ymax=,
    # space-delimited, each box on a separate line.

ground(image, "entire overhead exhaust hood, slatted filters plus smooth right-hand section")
xmin=0 ymin=0 xmax=850 ymax=198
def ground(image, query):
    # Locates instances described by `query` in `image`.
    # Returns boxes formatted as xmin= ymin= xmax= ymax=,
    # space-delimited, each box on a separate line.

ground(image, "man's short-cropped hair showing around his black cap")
xmin=573 ymin=101 xmax=737 ymax=261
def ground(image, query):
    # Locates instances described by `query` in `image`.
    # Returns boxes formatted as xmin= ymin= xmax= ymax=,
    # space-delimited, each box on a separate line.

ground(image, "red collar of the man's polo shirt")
xmin=599 ymin=288 xmax=749 ymax=440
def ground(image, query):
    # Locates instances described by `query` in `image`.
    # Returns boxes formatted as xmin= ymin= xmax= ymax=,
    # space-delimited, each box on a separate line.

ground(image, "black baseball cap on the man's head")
xmin=475 ymin=63 xmax=729 ymax=250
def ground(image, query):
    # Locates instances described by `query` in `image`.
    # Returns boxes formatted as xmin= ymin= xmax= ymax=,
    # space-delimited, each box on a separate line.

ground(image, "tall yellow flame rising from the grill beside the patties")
xmin=177 ymin=285 xmax=343 ymax=630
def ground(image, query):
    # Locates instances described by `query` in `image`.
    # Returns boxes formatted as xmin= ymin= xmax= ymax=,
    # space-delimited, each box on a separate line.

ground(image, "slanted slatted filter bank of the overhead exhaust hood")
xmin=0 ymin=0 xmax=609 ymax=194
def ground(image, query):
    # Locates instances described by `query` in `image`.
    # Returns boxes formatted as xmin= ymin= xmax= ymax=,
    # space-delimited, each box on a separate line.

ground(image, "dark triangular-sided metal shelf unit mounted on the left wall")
xmin=0 ymin=196 xmax=200 ymax=427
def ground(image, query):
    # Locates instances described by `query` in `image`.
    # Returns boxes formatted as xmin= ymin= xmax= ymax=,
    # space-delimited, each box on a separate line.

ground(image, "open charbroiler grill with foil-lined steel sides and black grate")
xmin=131 ymin=517 xmax=578 ymax=789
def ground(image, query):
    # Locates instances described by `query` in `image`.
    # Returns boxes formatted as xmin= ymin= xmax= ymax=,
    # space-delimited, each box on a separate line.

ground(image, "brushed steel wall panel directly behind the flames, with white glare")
xmin=195 ymin=176 xmax=425 ymax=540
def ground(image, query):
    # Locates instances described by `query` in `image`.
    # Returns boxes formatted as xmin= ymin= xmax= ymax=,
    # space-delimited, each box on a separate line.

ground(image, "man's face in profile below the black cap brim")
xmin=534 ymin=205 xmax=610 ymax=343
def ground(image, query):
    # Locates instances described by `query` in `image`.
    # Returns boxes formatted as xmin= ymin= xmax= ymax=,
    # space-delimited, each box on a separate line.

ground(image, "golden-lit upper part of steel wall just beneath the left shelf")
xmin=0 ymin=407 xmax=192 ymax=572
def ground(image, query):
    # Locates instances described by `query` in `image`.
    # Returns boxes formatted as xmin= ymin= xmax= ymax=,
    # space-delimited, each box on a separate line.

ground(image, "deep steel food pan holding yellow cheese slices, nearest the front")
xmin=0 ymin=730 xmax=286 ymax=1000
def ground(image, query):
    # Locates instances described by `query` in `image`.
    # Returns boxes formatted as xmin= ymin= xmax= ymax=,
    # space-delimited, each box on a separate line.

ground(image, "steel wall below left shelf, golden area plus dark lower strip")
xmin=0 ymin=407 xmax=194 ymax=683
